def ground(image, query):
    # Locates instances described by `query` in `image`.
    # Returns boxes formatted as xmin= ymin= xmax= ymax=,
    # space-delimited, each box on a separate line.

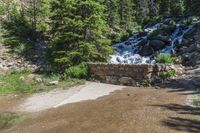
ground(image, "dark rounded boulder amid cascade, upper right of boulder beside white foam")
xmin=149 ymin=40 xmax=166 ymax=51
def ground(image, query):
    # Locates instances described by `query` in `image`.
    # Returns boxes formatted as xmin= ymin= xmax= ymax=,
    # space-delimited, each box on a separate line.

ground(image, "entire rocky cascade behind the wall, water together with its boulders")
xmin=109 ymin=17 xmax=200 ymax=64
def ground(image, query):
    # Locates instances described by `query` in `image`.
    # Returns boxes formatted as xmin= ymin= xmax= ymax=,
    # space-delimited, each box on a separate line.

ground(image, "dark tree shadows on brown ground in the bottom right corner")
xmin=155 ymin=104 xmax=200 ymax=133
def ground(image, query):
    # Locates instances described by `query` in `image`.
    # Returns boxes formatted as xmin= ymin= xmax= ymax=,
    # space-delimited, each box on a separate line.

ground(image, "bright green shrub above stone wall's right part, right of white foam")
xmin=155 ymin=54 xmax=176 ymax=64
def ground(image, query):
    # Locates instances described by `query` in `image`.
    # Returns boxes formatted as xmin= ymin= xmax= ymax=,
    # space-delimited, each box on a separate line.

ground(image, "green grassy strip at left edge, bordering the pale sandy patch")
xmin=0 ymin=70 xmax=84 ymax=94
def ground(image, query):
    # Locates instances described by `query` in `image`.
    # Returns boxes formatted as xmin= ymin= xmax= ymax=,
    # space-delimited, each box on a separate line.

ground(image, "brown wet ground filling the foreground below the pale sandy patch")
xmin=2 ymin=88 xmax=200 ymax=133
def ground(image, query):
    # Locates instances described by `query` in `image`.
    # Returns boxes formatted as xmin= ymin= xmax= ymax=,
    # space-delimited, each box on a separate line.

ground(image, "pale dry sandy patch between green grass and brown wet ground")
xmin=13 ymin=82 xmax=124 ymax=112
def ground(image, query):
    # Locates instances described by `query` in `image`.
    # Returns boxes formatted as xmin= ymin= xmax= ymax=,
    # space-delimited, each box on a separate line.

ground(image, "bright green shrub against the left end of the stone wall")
xmin=65 ymin=63 xmax=89 ymax=79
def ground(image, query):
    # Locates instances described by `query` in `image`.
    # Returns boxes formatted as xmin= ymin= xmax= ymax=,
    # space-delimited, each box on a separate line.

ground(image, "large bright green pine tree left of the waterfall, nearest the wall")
xmin=51 ymin=0 xmax=112 ymax=68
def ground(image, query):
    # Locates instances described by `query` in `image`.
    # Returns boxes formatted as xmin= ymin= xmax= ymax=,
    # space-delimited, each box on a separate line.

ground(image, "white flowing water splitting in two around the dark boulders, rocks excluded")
xmin=109 ymin=18 xmax=200 ymax=64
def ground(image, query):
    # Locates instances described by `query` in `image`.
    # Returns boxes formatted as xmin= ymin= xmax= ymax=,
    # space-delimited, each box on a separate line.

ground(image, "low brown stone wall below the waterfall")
xmin=89 ymin=64 xmax=177 ymax=86
